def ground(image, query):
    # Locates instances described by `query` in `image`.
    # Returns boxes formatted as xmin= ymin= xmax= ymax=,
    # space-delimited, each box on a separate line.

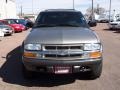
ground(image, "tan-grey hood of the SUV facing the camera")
xmin=24 ymin=27 xmax=100 ymax=44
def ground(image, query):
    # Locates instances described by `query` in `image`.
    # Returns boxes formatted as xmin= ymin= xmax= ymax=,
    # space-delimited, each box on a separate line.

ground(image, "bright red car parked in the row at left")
xmin=0 ymin=19 xmax=25 ymax=32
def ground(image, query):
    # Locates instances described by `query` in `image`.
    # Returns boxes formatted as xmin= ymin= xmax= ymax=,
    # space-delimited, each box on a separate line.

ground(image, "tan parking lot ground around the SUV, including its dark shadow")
xmin=0 ymin=24 xmax=120 ymax=90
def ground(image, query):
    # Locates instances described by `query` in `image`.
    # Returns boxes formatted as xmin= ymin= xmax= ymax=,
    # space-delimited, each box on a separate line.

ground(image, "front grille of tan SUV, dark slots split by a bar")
xmin=43 ymin=45 xmax=83 ymax=59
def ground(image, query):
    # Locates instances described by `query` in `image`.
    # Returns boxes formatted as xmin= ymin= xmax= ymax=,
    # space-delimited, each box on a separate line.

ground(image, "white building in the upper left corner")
xmin=0 ymin=0 xmax=17 ymax=19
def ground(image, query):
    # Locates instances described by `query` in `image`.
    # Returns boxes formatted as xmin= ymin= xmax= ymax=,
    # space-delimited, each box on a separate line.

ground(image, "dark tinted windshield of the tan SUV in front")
xmin=34 ymin=12 xmax=87 ymax=27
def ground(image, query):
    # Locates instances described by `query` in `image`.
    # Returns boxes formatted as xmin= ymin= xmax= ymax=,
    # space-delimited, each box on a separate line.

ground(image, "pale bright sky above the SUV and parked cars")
xmin=16 ymin=0 xmax=120 ymax=14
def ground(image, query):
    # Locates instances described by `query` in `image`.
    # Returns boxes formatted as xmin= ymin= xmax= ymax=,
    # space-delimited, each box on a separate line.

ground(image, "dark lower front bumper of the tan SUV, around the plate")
xmin=22 ymin=57 xmax=102 ymax=73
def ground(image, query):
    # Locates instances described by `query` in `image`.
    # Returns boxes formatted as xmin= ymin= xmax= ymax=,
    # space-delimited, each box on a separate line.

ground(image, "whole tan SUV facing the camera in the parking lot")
xmin=22 ymin=9 xmax=102 ymax=78
